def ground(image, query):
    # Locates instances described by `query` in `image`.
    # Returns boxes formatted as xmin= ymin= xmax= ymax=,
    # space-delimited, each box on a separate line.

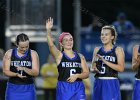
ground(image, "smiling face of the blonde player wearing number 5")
xmin=101 ymin=29 xmax=114 ymax=44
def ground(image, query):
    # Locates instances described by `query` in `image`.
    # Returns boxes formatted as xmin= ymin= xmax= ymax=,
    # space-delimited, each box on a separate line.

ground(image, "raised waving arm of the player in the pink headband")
xmin=46 ymin=17 xmax=61 ymax=59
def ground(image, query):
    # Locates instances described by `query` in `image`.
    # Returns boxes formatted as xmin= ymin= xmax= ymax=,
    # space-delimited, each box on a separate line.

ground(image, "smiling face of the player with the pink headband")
xmin=62 ymin=35 xmax=73 ymax=49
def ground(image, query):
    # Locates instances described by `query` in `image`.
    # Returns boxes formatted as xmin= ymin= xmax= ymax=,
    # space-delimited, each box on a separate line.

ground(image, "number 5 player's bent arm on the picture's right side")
xmin=98 ymin=47 xmax=125 ymax=72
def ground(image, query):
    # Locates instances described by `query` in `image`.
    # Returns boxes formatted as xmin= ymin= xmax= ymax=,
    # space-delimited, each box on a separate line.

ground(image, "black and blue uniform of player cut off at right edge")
xmin=132 ymin=46 xmax=140 ymax=100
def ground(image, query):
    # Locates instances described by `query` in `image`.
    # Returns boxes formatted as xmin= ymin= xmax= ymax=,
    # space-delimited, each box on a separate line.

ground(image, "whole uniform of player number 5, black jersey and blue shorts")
xmin=92 ymin=46 xmax=121 ymax=100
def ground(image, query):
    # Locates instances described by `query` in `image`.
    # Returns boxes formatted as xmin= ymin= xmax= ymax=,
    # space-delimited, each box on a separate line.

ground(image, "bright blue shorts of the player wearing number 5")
xmin=92 ymin=79 xmax=121 ymax=100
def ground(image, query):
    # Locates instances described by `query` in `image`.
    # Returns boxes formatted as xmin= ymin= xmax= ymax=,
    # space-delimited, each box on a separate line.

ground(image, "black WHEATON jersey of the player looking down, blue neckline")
xmin=9 ymin=48 xmax=34 ymax=84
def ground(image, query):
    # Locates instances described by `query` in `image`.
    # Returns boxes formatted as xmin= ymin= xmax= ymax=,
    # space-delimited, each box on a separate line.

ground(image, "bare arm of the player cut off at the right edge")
xmin=132 ymin=45 xmax=140 ymax=70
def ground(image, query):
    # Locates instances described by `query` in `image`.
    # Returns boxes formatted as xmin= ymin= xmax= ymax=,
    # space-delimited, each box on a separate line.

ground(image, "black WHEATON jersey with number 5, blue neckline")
xmin=95 ymin=46 xmax=118 ymax=77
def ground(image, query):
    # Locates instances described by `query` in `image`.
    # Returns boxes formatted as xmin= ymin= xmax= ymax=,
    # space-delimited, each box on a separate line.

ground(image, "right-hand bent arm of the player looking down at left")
xmin=23 ymin=50 xmax=39 ymax=76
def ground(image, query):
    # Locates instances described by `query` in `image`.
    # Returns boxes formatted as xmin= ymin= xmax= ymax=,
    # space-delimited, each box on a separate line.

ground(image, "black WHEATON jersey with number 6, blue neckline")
xmin=57 ymin=52 xmax=82 ymax=81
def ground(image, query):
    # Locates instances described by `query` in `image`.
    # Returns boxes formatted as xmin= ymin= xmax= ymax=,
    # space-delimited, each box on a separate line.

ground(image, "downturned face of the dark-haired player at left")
xmin=18 ymin=41 xmax=29 ymax=54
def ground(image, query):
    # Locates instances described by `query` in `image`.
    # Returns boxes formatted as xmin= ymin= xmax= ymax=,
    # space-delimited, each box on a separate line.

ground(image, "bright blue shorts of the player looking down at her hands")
xmin=5 ymin=82 xmax=36 ymax=100
